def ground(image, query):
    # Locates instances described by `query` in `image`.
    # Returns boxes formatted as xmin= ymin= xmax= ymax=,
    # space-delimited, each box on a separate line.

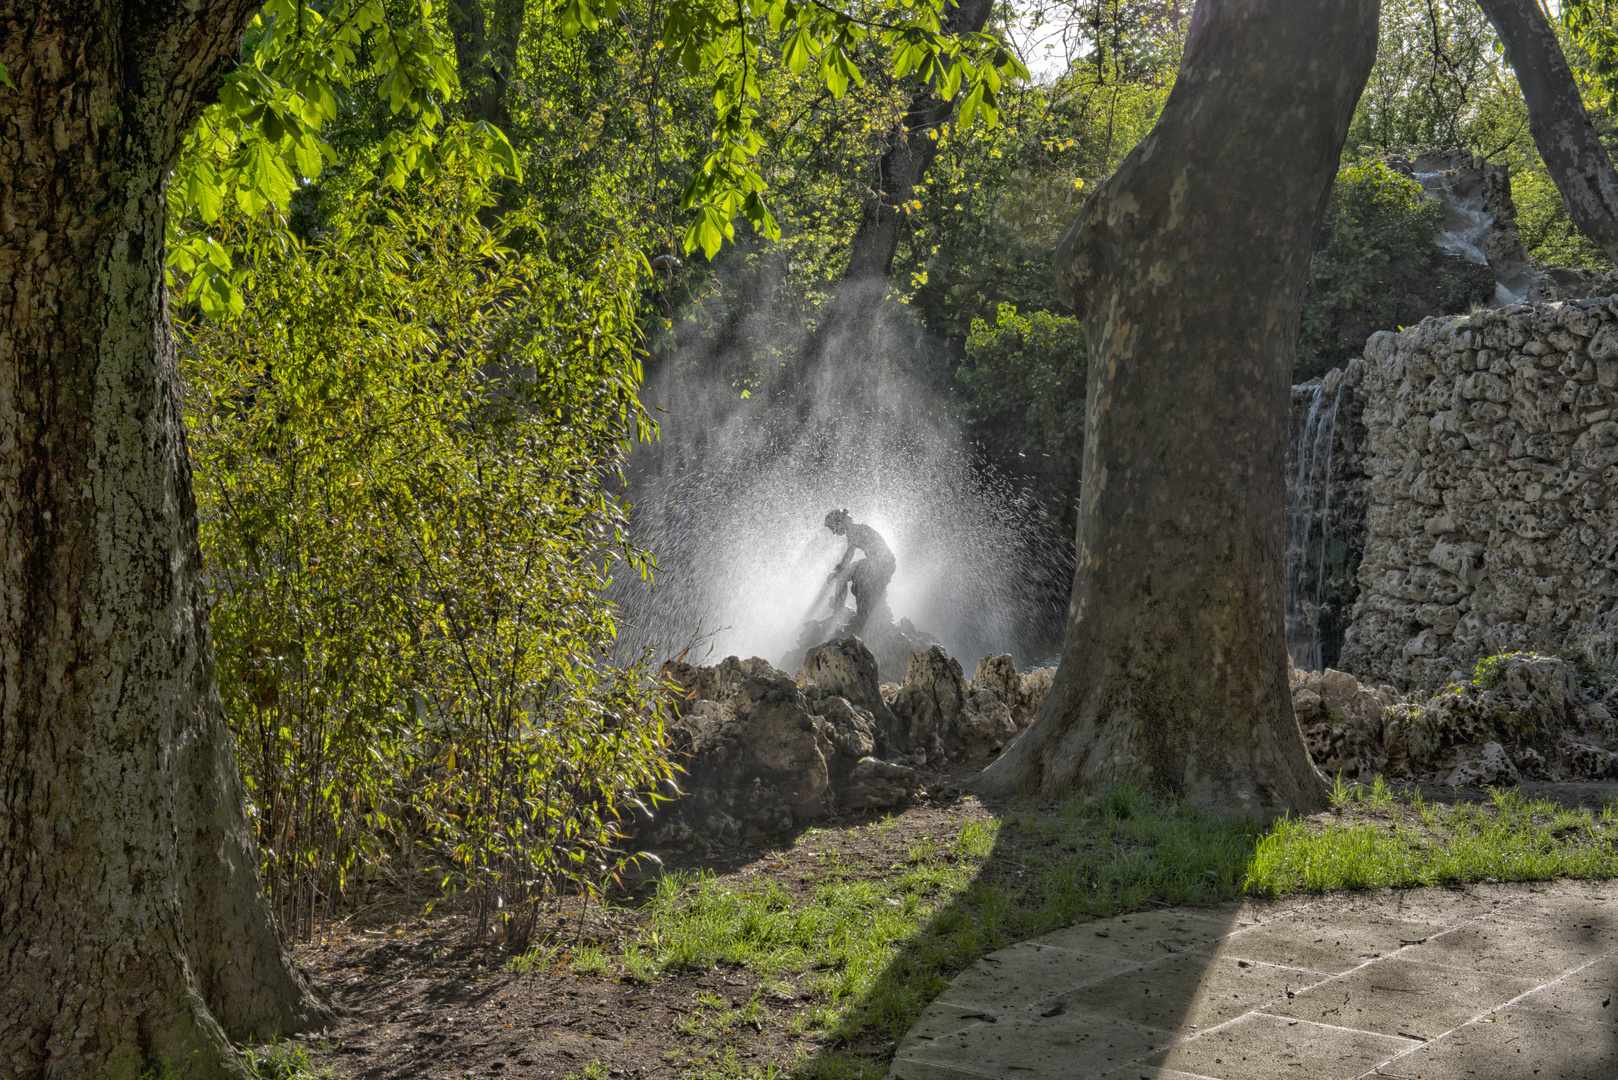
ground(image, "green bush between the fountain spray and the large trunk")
xmin=956 ymin=304 xmax=1087 ymax=495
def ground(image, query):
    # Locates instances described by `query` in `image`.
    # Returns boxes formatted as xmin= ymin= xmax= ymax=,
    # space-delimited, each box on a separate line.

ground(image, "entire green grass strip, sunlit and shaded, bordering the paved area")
xmin=539 ymin=780 xmax=1618 ymax=1080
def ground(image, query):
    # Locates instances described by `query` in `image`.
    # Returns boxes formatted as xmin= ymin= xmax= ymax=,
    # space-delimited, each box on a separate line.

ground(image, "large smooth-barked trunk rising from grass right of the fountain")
xmin=974 ymin=0 xmax=1379 ymax=813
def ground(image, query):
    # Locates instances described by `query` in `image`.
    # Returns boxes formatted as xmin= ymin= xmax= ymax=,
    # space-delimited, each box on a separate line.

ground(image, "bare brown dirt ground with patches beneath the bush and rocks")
xmin=294 ymin=777 xmax=989 ymax=1080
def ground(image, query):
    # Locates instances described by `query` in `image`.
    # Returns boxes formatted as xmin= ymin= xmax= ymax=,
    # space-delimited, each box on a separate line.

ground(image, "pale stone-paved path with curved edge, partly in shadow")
xmin=888 ymin=881 xmax=1618 ymax=1080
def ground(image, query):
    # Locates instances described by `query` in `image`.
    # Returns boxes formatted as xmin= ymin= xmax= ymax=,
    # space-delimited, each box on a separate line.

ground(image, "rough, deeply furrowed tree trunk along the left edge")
xmin=0 ymin=0 xmax=324 ymax=1080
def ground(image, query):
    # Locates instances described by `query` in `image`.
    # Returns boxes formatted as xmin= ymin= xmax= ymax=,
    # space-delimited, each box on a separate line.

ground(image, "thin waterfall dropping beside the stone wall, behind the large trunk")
xmin=1286 ymin=369 xmax=1343 ymax=670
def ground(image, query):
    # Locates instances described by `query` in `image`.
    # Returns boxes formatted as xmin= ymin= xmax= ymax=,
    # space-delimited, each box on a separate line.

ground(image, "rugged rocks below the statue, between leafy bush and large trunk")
xmin=650 ymin=638 xmax=1053 ymax=847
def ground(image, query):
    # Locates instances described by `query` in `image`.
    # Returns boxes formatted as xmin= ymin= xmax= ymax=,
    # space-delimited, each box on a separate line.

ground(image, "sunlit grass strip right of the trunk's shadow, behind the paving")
xmin=1246 ymin=779 xmax=1618 ymax=895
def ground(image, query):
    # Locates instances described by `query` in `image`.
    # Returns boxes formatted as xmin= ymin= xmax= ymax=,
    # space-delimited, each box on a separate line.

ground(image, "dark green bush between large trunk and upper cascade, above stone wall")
xmin=1293 ymin=160 xmax=1495 ymax=382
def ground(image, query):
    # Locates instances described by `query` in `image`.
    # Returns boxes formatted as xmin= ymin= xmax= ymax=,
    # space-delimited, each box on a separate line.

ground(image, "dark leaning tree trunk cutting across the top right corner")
xmin=1477 ymin=0 xmax=1618 ymax=262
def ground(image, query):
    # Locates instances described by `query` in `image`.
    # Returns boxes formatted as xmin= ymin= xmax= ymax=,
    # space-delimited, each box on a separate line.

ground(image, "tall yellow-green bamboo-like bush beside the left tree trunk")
xmin=184 ymin=175 xmax=668 ymax=938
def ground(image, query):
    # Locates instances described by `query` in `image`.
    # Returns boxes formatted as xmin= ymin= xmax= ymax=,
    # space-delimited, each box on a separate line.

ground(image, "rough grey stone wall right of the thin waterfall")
xmin=1338 ymin=296 xmax=1618 ymax=688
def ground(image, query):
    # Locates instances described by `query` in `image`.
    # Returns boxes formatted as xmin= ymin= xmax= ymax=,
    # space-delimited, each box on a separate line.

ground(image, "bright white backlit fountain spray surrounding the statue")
xmin=613 ymin=276 xmax=1071 ymax=667
